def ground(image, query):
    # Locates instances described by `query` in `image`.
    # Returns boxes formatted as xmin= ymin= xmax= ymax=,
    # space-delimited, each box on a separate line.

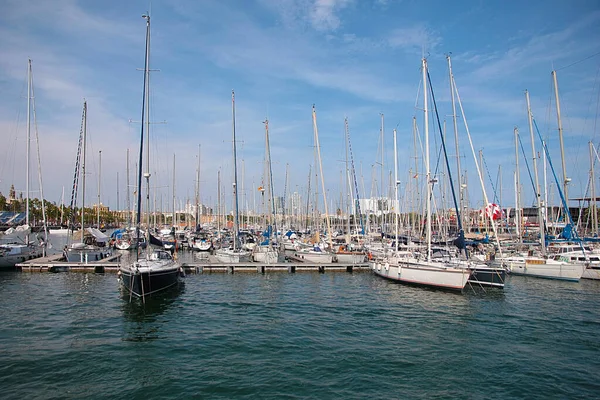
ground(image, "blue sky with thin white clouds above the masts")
xmin=0 ymin=0 xmax=600 ymax=216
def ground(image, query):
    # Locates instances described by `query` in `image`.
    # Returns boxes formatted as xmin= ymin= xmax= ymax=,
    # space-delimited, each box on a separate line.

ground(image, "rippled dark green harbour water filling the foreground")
xmin=0 ymin=262 xmax=600 ymax=399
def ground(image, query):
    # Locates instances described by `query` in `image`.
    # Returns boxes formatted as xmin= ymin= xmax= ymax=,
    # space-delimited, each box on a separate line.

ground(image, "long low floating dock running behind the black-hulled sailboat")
xmin=16 ymin=253 xmax=369 ymax=274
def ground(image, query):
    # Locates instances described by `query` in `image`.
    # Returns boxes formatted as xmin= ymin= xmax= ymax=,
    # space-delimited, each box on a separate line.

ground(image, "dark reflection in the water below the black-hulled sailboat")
xmin=121 ymin=282 xmax=185 ymax=342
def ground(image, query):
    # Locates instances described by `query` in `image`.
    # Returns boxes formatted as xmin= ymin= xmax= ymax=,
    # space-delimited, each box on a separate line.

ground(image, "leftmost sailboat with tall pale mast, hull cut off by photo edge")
xmin=0 ymin=60 xmax=45 ymax=269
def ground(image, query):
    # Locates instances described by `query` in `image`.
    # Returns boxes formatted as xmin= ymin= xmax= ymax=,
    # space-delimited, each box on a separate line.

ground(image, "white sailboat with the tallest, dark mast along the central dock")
xmin=215 ymin=90 xmax=252 ymax=264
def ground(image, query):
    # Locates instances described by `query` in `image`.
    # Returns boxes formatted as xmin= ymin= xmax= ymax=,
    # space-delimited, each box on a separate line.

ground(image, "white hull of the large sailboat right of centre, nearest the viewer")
xmin=370 ymin=259 xmax=471 ymax=290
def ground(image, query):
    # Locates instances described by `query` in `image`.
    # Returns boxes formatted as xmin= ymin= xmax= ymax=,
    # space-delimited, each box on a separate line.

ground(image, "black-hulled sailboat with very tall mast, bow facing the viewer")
xmin=119 ymin=15 xmax=184 ymax=302
